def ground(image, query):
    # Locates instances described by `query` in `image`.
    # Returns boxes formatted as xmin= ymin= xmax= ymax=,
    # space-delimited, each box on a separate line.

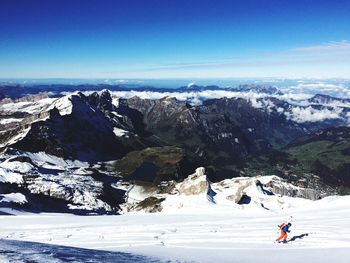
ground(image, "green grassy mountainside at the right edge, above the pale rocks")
xmin=245 ymin=127 xmax=350 ymax=194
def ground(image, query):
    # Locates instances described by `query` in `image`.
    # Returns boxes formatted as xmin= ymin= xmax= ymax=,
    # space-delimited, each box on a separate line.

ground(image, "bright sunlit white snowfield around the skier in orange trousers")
xmin=0 ymin=197 xmax=350 ymax=263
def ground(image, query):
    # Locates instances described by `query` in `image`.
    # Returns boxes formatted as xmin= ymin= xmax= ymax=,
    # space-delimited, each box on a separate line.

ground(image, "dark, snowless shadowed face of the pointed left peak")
xmin=12 ymin=96 xmax=126 ymax=160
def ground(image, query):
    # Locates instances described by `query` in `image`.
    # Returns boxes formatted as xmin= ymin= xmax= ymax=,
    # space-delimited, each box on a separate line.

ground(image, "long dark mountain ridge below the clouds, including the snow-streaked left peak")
xmin=0 ymin=87 xmax=348 ymax=178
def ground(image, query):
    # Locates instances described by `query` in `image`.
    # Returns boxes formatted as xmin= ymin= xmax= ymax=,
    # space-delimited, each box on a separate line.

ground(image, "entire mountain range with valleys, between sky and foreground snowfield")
xmin=0 ymin=85 xmax=350 ymax=216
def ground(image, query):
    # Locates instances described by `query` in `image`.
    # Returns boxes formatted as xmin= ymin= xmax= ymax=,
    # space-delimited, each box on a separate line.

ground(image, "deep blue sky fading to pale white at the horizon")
xmin=0 ymin=0 xmax=350 ymax=78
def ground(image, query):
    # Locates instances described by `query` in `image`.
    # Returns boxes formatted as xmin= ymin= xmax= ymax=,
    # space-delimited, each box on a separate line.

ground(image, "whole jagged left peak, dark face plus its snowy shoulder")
xmin=3 ymin=92 xmax=149 ymax=162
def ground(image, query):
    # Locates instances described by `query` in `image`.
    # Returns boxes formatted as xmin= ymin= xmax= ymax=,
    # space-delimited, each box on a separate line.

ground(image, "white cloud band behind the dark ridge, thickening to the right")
xmin=100 ymin=82 xmax=350 ymax=123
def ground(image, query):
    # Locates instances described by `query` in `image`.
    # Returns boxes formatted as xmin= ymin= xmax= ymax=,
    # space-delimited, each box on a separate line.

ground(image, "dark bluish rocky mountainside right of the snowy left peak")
xmin=123 ymin=97 xmax=345 ymax=180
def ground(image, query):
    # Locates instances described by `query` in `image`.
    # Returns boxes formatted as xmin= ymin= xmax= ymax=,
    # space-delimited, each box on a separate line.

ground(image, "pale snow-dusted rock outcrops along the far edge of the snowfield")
xmin=117 ymin=167 xmax=324 ymax=216
